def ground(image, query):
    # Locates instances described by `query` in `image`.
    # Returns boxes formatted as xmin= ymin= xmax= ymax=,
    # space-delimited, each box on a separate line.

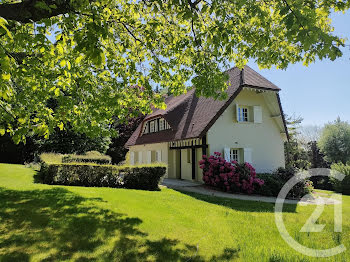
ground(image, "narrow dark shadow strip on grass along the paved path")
xmin=174 ymin=189 xmax=297 ymax=213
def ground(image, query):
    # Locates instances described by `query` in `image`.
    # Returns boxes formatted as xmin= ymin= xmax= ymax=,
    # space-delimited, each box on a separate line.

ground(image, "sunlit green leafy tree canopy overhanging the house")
xmin=0 ymin=0 xmax=350 ymax=142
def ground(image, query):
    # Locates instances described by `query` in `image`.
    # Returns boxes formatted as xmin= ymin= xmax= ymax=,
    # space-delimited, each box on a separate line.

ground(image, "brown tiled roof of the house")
xmin=125 ymin=66 xmax=280 ymax=147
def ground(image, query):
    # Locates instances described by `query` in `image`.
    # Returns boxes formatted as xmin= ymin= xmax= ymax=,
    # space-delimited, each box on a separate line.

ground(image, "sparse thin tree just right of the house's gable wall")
xmin=284 ymin=115 xmax=310 ymax=169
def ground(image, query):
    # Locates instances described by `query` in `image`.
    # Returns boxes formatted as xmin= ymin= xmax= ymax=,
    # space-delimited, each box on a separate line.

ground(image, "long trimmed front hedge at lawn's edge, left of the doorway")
xmin=37 ymin=163 xmax=166 ymax=190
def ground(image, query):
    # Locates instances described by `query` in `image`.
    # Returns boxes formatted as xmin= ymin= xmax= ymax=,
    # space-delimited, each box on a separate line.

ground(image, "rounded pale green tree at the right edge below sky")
xmin=318 ymin=117 xmax=350 ymax=164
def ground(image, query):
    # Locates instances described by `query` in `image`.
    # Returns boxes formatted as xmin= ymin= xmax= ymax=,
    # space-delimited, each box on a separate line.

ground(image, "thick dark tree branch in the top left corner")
xmin=0 ymin=0 xmax=71 ymax=23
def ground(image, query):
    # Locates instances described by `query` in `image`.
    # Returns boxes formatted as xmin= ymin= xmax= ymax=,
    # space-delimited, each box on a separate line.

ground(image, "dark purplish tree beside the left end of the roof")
xmin=107 ymin=115 xmax=144 ymax=164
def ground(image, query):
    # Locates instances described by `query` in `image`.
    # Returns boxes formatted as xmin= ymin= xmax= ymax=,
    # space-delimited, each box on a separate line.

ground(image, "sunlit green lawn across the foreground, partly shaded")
xmin=0 ymin=164 xmax=350 ymax=262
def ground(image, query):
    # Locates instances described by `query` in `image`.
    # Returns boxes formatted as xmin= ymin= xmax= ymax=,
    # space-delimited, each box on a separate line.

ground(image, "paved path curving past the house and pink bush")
xmin=162 ymin=178 xmax=339 ymax=205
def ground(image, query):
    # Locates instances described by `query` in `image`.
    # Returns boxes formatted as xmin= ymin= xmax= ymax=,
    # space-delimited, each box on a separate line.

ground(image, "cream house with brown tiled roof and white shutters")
xmin=125 ymin=66 xmax=288 ymax=181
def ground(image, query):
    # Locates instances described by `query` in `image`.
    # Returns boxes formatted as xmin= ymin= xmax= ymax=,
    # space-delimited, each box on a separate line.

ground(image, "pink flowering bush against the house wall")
xmin=199 ymin=152 xmax=264 ymax=194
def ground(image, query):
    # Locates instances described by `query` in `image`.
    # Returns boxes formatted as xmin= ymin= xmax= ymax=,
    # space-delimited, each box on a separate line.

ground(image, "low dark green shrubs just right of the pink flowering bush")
xmin=257 ymin=167 xmax=313 ymax=198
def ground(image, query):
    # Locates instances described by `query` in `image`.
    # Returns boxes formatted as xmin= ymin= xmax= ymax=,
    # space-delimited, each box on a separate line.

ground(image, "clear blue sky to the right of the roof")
xmin=248 ymin=11 xmax=350 ymax=125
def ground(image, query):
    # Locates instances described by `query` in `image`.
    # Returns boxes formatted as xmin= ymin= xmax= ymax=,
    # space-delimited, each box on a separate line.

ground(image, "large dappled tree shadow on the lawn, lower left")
xmin=0 ymin=188 xmax=238 ymax=262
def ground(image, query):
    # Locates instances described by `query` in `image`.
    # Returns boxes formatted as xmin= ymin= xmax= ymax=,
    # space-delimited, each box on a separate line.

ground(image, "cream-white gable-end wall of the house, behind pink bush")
xmin=207 ymin=90 xmax=285 ymax=172
